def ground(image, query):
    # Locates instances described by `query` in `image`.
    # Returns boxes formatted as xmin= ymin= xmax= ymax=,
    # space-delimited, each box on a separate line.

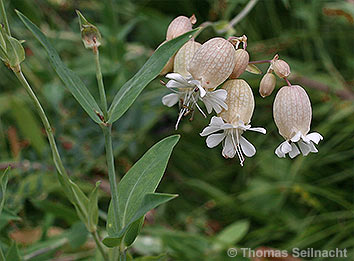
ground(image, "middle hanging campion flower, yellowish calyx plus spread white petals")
xmin=200 ymin=79 xmax=266 ymax=166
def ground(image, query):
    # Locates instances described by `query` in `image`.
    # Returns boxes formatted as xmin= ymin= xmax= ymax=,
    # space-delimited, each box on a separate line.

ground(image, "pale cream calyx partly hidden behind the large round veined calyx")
xmin=173 ymin=40 xmax=202 ymax=77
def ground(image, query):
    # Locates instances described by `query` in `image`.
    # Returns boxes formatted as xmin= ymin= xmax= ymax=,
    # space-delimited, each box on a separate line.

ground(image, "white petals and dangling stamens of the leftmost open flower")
xmin=162 ymin=73 xmax=227 ymax=129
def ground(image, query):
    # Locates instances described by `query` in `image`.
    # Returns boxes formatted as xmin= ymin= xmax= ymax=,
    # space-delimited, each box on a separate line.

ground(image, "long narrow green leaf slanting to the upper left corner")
xmin=16 ymin=10 xmax=103 ymax=123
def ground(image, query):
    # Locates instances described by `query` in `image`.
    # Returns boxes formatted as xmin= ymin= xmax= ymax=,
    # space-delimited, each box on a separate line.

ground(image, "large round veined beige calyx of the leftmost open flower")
xmin=187 ymin=37 xmax=235 ymax=90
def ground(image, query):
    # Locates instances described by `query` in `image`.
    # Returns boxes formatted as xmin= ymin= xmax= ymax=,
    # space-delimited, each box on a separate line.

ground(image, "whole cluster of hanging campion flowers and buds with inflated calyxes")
xmin=156 ymin=16 xmax=323 ymax=165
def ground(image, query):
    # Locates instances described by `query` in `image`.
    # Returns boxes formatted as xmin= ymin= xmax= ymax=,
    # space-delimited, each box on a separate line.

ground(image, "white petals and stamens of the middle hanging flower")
xmin=200 ymin=116 xmax=266 ymax=166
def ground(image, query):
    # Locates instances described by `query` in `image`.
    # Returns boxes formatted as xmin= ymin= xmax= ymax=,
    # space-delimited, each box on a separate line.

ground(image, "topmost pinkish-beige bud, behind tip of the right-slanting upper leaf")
xmin=166 ymin=15 xmax=197 ymax=41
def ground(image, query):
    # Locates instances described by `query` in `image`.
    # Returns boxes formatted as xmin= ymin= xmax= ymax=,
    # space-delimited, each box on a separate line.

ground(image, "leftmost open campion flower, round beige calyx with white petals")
xmin=162 ymin=38 xmax=235 ymax=129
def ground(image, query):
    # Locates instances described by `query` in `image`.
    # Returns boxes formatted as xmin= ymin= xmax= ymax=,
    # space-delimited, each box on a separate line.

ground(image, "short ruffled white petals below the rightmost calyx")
xmin=275 ymin=131 xmax=323 ymax=158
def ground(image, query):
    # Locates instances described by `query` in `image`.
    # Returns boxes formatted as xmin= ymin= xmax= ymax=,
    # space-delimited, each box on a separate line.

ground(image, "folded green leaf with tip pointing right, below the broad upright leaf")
xmin=103 ymin=193 xmax=178 ymax=247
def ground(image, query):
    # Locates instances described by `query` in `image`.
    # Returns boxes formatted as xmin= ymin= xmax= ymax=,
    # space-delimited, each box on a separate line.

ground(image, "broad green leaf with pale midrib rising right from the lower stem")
xmin=103 ymin=135 xmax=180 ymax=245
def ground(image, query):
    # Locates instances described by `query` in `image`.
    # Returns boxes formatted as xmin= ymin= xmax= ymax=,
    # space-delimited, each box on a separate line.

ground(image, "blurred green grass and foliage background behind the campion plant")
xmin=0 ymin=0 xmax=354 ymax=260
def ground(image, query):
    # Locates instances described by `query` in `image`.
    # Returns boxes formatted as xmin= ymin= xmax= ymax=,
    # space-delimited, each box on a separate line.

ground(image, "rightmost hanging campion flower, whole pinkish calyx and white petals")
xmin=273 ymin=85 xmax=323 ymax=158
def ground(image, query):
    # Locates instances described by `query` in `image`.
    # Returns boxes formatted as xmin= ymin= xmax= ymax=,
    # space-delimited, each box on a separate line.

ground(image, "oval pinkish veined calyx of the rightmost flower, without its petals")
xmin=273 ymin=85 xmax=312 ymax=140
